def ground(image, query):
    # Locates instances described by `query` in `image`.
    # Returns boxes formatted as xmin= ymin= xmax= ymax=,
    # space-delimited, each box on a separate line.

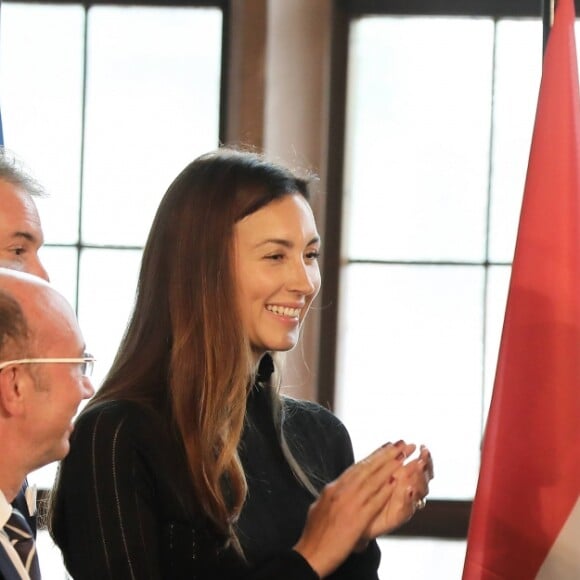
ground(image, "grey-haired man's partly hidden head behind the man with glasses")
xmin=0 ymin=148 xmax=48 ymax=280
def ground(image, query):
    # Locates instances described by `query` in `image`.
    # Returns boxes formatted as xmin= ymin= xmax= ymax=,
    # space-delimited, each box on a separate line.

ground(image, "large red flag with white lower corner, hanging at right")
xmin=463 ymin=0 xmax=580 ymax=580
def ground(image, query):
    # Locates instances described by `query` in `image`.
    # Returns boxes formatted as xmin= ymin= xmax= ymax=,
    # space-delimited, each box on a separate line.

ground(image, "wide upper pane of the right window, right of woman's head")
xmin=345 ymin=17 xmax=494 ymax=260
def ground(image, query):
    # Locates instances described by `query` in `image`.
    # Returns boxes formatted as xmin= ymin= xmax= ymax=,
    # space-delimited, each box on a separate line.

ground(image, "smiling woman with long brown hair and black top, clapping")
xmin=51 ymin=149 xmax=432 ymax=580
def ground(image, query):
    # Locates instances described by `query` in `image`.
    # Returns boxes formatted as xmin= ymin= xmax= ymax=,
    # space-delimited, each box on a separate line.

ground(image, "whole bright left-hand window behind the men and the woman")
xmin=0 ymin=1 xmax=224 ymax=578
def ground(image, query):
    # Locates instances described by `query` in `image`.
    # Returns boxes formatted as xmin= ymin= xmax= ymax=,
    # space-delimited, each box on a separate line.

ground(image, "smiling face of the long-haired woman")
xmin=234 ymin=193 xmax=320 ymax=355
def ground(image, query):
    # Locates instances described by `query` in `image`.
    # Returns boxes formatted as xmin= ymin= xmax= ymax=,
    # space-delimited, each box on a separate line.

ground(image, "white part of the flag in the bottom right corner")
xmin=536 ymin=497 xmax=580 ymax=580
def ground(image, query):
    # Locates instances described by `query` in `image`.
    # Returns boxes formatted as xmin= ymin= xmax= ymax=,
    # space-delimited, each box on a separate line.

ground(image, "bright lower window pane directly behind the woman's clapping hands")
xmin=337 ymin=265 xmax=484 ymax=498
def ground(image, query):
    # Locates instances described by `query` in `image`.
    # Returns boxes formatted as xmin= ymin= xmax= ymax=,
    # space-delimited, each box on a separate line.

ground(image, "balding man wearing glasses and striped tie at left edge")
xmin=0 ymin=268 xmax=94 ymax=580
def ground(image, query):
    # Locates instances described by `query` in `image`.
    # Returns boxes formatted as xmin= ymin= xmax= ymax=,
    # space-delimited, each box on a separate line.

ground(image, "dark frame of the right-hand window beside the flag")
xmin=318 ymin=0 xmax=556 ymax=539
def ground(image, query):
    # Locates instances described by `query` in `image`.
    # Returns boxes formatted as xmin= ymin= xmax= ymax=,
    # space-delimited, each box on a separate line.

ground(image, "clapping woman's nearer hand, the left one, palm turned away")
xmin=294 ymin=441 xmax=415 ymax=578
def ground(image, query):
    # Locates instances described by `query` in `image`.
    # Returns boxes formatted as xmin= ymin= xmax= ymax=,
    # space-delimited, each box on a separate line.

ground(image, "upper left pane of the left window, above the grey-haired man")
xmin=0 ymin=2 xmax=84 ymax=243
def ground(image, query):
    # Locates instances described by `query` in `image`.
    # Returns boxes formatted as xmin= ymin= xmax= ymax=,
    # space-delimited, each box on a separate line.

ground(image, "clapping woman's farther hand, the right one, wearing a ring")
xmin=359 ymin=445 xmax=433 ymax=548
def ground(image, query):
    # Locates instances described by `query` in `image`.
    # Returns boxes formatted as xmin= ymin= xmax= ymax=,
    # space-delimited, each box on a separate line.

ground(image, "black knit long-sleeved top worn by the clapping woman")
xmin=53 ymin=356 xmax=380 ymax=580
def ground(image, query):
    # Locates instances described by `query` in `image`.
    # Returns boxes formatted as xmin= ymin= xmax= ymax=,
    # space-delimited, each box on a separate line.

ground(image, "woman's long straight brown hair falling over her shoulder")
xmin=78 ymin=149 xmax=309 ymax=549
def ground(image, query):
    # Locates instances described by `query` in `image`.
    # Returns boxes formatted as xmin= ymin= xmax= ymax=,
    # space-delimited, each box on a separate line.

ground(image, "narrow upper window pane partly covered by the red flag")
xmin=489 ymin=19 xmax=542 ymax=262
